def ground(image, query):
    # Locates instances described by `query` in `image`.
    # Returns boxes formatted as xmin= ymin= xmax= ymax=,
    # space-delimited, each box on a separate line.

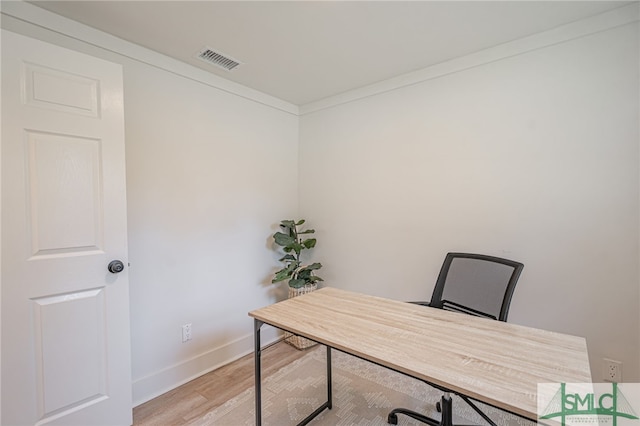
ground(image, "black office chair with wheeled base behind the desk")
xmin=387 ymin=253 xmax=524 ymax=426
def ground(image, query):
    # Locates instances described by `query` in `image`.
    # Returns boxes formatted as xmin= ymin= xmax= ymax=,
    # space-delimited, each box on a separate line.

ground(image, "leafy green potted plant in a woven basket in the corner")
xmin=271 ymin=219 xmax=323 ymax=349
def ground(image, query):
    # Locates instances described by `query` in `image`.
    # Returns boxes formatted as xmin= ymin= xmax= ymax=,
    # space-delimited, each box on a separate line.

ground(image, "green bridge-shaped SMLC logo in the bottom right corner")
xmin=540 ymin=383 xmax=638 ymax=426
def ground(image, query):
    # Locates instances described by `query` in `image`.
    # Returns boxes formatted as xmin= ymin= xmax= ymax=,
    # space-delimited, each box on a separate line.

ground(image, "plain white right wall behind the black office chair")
xmin=300 ymin=23 xmax=640 ymax=381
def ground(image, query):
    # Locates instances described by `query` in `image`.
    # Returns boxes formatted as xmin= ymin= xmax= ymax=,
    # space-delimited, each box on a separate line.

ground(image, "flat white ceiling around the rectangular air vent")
xmin=30 ymin=0 xmax=630 ymax=105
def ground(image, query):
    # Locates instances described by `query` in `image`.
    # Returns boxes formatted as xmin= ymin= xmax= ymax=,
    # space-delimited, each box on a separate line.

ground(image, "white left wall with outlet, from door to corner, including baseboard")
xmin=3 ymin=5 xmax=298 ymax=405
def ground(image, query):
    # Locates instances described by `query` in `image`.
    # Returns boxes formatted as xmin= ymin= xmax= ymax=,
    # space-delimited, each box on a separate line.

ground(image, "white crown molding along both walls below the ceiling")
xmin=0 ymin=0 xmax=640 ymax=116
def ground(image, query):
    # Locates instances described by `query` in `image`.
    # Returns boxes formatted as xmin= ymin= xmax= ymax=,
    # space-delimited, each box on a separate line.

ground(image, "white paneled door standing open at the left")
xmin=0 ymin=31 xmax=132 ymax=426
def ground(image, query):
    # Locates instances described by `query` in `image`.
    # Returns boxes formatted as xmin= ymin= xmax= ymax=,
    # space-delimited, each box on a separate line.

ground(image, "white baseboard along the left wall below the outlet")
xmin=132 ymin=327 xmax=281 ymax=407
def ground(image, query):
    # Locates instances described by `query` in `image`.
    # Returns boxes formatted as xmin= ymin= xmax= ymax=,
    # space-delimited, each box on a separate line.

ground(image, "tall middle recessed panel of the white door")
xmin=26 ymin=131 xmax=104 ymax=255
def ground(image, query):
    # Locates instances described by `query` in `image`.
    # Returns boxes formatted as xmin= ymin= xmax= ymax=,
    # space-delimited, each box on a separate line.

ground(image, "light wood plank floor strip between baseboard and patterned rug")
xmin=133 ymin=342 xmax=306 ymax=426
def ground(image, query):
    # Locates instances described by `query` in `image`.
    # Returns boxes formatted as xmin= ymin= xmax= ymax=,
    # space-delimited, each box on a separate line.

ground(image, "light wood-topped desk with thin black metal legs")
xmin=249 ymin=288 xmax=591 ymax=425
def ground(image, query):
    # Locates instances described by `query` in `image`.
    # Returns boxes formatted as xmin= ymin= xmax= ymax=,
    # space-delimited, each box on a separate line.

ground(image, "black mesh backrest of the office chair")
xmin=429 ymin=253 xmax=524 ymax=321
